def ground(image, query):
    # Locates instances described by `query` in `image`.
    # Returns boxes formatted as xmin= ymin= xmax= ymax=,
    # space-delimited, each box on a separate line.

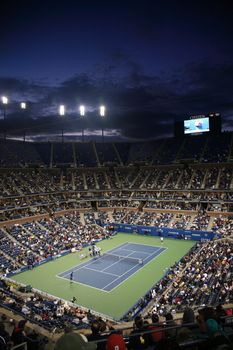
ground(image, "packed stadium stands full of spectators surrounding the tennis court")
xmin=0 ymin=134 xmax=233 ymax=350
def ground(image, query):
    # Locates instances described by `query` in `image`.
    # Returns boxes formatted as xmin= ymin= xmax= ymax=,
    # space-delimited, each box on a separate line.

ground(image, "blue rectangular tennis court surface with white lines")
xmin=58 ymin=242 xmax=166 ymax=292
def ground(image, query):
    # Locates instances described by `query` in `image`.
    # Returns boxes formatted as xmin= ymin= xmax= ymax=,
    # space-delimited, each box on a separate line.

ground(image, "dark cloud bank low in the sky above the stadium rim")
xmin=0 ymin=57 xmax=233 ymax=139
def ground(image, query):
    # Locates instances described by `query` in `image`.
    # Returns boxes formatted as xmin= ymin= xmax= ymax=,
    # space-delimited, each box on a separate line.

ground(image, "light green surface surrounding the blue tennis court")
xmin=12 ymin=233 xmax=195 ymax=320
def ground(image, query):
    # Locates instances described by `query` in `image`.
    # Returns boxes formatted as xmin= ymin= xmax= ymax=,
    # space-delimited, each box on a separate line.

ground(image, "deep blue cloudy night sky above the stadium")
xmin=0 ymin=0 xmax=233 ymax=140
